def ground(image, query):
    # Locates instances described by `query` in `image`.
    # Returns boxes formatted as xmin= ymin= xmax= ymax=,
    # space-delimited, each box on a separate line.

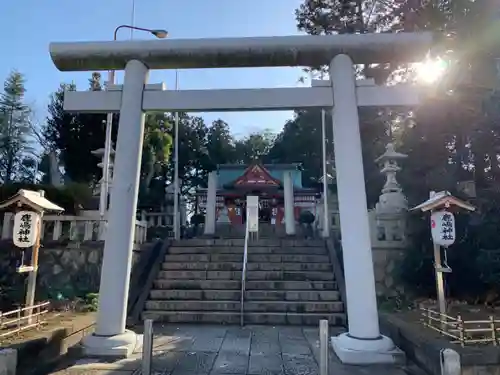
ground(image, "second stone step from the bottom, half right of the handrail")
xmin=244 ymin=301 xmax=344 ymax=313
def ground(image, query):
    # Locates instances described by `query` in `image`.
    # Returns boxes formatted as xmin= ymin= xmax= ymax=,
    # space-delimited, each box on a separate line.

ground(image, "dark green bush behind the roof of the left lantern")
xmin=0 ymin=183 xmax=92 ymax=215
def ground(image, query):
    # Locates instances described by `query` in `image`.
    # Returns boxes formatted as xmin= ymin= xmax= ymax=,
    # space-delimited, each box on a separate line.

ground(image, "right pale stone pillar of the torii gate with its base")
xmin=330 ymin=55 xmax=395 ymax=364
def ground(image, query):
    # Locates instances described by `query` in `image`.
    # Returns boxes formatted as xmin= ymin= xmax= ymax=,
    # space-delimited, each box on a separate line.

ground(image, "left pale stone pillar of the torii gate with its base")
xmin=83 ymin=60 xmax=148 ymax=357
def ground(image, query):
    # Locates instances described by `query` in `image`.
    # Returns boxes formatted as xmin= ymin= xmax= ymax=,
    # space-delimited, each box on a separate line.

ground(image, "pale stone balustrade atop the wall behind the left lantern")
xmin=2 ymin=212 xmax=147 ymax=244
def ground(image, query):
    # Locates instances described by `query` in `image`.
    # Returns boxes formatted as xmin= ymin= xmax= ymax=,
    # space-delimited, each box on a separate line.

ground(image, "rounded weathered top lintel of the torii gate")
xmin=50 ymin=32 xmax=433 ymax=71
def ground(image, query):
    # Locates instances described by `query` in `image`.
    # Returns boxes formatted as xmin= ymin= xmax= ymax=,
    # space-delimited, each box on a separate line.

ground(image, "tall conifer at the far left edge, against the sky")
xmin=0 ymin=71 xmax=34 ymax=184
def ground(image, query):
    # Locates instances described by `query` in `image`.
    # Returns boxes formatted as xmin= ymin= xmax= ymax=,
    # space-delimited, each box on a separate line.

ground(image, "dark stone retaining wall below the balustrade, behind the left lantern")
xmin=0 ymin=240 xmax=146 ymax=304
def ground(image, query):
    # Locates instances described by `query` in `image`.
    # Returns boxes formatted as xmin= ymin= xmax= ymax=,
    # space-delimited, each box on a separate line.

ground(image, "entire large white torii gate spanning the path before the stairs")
xmin=50 ymin=33 xmax=432 ymax=364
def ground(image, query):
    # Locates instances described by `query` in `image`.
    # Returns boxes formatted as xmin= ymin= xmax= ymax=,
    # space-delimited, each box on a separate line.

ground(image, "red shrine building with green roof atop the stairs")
xmin=197 ymin=163 xmax=320 ymax=225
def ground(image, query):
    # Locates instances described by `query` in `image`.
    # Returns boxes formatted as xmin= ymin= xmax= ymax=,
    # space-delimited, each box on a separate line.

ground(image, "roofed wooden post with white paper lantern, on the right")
xmin=412 ymin=191 xmax=475 ymax=331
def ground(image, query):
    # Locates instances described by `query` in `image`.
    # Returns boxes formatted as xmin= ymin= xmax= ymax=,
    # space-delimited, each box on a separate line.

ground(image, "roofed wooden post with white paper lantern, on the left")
xmin=0 ymin=189 xmax=64 ymax=324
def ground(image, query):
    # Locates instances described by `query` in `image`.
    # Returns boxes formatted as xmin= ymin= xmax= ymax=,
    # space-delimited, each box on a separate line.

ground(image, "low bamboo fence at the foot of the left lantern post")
xmin=0 ymin=302 xmax=50 ymax=340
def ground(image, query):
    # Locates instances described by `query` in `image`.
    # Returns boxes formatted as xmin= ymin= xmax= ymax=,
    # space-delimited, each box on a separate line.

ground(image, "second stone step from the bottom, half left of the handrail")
xmin=145 ymin=300 xmax=240 ymax=311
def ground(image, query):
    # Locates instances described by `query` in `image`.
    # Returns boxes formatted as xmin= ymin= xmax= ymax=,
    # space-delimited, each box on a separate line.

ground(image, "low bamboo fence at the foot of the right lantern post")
xmin=420 ymin=308 xmax=500 ymax=347
